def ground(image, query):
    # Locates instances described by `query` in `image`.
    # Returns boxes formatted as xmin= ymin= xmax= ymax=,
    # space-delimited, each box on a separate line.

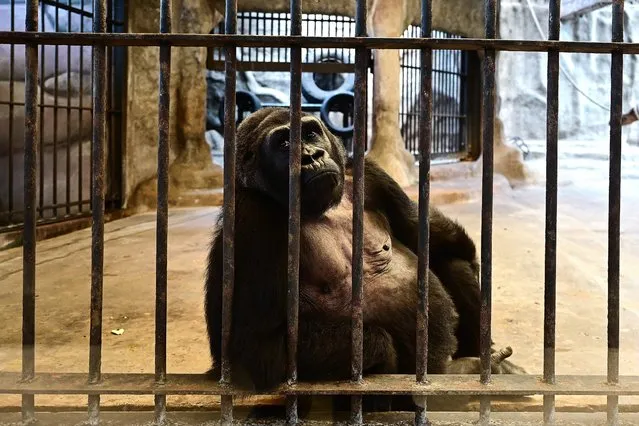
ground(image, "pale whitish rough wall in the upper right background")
xmin=498 ymin=0 xmax=639 ymax=143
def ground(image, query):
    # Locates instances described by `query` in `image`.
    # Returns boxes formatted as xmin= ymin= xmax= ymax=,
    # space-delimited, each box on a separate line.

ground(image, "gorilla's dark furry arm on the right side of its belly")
xmin=364 ymin=160 xmax=481 ymax=357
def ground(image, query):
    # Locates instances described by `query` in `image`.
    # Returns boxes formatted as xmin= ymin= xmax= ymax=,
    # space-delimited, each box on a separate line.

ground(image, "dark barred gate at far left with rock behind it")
xmin=0 ymin=0 xmax=126 ymax=232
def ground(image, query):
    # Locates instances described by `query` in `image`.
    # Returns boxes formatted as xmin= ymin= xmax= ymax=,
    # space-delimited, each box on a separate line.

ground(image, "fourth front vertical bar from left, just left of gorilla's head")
xmin=221 ymin=0 xmax=237 ymax=425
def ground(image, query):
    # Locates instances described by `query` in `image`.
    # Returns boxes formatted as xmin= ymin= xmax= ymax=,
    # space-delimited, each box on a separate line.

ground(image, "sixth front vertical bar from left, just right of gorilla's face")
xmin=351 ymin=0 xmax=369 ymax=425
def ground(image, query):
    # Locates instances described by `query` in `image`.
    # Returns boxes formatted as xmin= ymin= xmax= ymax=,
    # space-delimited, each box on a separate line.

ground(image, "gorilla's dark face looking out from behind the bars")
xmin=259 ymin=115 xmax=345 ymax=217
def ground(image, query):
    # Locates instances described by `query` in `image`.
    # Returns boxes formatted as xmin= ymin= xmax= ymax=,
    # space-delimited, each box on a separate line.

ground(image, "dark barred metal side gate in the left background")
xmin=0 ymin=0 xmax=127 ymax=232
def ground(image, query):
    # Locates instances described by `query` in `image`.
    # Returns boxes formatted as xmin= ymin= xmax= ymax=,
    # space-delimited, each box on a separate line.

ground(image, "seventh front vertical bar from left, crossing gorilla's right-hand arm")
xmin=415 ymin=0 xmax=433 ymax=425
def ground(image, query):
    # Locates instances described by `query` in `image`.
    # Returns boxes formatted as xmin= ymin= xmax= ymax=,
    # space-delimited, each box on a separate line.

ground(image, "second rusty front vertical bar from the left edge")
xmin=89 ymin=0 xmax=107 ymax=425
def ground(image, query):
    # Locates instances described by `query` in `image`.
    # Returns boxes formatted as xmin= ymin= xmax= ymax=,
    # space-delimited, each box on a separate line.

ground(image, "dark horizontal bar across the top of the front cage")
xmin=0 ymin=31 xmax=639 ymax=54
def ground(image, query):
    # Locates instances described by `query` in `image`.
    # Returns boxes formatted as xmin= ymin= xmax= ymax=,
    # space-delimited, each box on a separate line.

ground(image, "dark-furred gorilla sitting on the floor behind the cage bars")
xmin=205 ymin=108 xmax=523 ymax=414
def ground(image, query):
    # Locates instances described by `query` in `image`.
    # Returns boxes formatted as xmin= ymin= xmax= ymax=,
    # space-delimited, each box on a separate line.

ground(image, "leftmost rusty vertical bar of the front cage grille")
xmin=22 ymin=0 xmax=40 ymax=423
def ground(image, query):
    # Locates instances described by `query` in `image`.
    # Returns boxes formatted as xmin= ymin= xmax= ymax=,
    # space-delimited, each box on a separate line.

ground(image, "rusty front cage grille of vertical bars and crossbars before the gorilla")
xmin=0 ymin=0 xmax=639 ymax=425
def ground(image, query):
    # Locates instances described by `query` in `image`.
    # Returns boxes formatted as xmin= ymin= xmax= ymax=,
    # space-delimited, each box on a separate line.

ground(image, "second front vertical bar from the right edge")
xmin=544 ymin=0 xmax=561 ymax=424
